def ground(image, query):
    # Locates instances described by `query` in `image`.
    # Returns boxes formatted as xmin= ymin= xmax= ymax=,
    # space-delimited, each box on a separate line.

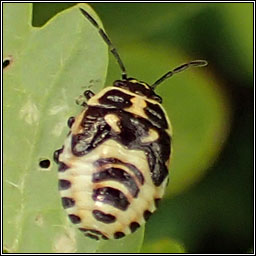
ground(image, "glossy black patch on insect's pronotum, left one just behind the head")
xmin=99 ymin=90 xmax=134 ymax=109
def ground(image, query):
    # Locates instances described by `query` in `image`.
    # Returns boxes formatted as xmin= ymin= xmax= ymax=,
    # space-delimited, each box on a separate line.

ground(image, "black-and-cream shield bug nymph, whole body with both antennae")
xmin=54 ymin=8 xmax=207 ymax=240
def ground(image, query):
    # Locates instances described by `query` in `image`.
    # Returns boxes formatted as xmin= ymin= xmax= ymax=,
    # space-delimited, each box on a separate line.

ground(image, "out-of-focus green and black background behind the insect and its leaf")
xmin=5 ymin=3 xmax=254 ymax=253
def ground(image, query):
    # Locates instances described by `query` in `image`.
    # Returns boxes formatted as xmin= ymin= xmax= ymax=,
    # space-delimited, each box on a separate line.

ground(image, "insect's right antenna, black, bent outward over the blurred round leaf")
xmin=151 ymin=60 xmax=208 ymax=90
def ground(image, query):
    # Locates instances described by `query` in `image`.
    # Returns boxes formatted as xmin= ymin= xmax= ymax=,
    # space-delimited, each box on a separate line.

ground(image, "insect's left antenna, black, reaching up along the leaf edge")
xmin=79 ymin=8 xmax=127 ymax=80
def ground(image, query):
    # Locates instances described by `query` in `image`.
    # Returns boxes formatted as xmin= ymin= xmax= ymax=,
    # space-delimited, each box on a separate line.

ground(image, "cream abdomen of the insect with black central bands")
xmin=59 ymin=140 xmax=161 ymax=238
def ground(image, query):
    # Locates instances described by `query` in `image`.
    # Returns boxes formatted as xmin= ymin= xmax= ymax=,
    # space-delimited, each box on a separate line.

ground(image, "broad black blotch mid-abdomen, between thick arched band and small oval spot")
xmin=92 ymin=187 xmax=130 ymax=211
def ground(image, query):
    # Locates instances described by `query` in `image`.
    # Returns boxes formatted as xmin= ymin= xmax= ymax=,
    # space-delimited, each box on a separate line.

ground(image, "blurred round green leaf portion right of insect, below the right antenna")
xmin=163 ymin=63 xmax=230 ymax=195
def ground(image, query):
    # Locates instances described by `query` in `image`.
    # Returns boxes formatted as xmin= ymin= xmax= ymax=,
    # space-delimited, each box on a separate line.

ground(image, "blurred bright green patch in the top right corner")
xmin=220 ymin=3 xmax=254 ymax=86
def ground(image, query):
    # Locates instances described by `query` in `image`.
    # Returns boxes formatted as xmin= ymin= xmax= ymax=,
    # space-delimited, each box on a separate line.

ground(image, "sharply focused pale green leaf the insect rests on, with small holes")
xmin=3 ymin=3 xmax=119 ymax=253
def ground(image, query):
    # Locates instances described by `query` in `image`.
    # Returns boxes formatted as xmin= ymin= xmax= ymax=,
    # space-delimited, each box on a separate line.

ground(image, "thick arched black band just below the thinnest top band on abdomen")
xmin=92 ymin=167 xmax=140 ymax=197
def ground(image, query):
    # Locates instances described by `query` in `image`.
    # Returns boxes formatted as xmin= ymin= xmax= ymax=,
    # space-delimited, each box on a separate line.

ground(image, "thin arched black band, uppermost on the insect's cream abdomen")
xmin=94 ymin=158 xmax=144 ymax=185
